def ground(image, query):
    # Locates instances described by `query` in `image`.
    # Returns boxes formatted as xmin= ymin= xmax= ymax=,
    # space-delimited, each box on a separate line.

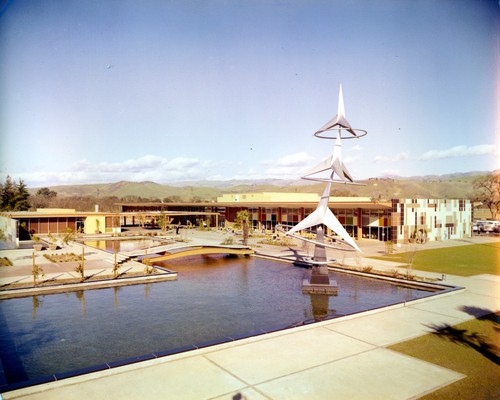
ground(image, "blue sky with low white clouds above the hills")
xmin=0 ymin=0 xmax=500 ymax=187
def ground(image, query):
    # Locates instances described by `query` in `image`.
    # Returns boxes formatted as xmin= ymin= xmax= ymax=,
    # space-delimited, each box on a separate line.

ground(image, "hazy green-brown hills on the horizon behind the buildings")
xmin=30 ymin=172 xmax=490 ymax=202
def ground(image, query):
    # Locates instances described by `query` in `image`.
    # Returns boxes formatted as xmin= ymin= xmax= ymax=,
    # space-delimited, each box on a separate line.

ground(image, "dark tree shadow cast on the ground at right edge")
xmin=426 ymin=306 xmax=500 ymax=365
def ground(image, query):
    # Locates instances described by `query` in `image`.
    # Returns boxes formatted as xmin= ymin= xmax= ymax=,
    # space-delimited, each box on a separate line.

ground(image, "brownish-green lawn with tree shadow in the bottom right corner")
xmin=389 ymin=314 xmax=500 ymax=400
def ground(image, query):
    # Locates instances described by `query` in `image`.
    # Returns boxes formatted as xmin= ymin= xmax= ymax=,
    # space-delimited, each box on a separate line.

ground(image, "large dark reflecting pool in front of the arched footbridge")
xmin=0 ymin=256 xmax=438 ymax=389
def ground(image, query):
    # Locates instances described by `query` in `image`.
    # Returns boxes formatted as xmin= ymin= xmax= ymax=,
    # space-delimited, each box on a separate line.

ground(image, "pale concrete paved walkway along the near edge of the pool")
xmin=3 ymin=233 xmax=500 ymax=400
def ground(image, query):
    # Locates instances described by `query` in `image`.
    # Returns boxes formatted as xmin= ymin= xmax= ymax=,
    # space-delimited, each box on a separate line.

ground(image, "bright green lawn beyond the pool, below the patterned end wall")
xmin=371 ymin=243 xmax=500 ymax=276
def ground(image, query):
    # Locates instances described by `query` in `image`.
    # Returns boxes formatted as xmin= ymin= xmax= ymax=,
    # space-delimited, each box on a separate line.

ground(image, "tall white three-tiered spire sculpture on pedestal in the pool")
xmin=278 ymin=85 xmax=367 ymax=294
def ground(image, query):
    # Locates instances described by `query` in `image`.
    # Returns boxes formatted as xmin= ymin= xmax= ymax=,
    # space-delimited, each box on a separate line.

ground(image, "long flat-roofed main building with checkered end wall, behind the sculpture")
xmin=118 ymin=192 xmax=472 ymax=243
